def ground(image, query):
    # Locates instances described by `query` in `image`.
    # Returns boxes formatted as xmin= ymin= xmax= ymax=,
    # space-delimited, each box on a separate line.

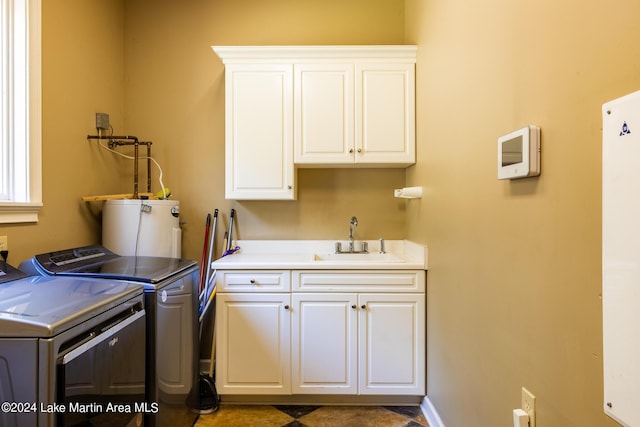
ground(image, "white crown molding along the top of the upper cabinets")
xmin=211 ymin=45 xmax=418 ymax=64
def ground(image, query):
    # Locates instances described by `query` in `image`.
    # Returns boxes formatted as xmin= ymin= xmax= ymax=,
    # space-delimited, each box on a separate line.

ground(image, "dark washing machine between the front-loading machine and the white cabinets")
xmin=20 ymin=245 xmax=200 ymax=426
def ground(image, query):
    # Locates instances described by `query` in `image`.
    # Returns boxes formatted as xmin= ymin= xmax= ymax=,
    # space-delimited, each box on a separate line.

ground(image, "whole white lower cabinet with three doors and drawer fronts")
xmin=216 ymin=271 xmax=426 ymax=396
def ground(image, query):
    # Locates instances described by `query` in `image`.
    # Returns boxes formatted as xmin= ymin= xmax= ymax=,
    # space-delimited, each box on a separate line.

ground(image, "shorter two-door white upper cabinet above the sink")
xmin=293 ymin=58 xmax=416 ymax=167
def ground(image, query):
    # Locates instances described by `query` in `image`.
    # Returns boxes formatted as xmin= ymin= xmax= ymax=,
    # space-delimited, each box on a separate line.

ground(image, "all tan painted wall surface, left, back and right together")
xmin=6 ymin=0 xmax=624 ymax=427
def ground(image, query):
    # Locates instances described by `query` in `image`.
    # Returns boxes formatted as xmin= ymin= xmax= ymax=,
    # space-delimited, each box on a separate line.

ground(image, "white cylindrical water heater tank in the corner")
xmin=102 ymin=199 xmax=182 ymax=258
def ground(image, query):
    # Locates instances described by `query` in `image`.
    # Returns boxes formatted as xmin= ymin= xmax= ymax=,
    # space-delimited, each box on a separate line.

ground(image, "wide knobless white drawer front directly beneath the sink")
xmin=291 ymin=270 xmax=425 ymax=292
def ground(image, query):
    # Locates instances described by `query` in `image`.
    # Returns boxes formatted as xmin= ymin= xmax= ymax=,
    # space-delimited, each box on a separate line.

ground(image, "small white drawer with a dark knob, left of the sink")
xmin=216 ymin=270 xmax=291 ymax=292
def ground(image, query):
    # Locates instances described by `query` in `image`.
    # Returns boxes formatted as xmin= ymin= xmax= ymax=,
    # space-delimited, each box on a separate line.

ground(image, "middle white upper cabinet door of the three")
xmin=293 ymin=63 xmax=355 ymax=165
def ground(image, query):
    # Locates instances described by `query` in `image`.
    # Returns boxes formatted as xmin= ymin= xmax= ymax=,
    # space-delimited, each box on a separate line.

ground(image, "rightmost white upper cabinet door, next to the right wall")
xmin=355 ymin=63 xmax=416 ymax=166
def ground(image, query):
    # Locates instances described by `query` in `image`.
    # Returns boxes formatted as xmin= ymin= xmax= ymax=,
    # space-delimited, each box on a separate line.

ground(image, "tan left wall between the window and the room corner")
xmin=0 ymin=0 xmax=122 ymax=265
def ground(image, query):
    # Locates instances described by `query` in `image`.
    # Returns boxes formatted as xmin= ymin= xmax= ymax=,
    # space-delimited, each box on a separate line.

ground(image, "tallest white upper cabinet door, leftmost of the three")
xmin=225 ymin=64 xmax=295 ymax=200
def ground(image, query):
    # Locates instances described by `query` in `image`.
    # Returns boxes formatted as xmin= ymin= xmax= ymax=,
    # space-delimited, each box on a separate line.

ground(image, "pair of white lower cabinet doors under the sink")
xmin=291 ymin=293 xmax=425 ymax=395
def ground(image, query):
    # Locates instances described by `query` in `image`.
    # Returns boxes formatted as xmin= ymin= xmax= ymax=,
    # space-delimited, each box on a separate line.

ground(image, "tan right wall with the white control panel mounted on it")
xmin=406 ymin=0 xmax=640 ymax=427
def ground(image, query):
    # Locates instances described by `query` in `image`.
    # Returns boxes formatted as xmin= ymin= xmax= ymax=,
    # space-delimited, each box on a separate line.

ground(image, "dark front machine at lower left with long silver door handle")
xmin=0 ymin=262 xmax=146 ymax=427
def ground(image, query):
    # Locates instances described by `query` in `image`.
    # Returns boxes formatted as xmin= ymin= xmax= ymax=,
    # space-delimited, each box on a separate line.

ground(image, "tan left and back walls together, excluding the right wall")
xmin=0 ymin=0 xmax=405 ymax=264
